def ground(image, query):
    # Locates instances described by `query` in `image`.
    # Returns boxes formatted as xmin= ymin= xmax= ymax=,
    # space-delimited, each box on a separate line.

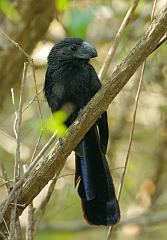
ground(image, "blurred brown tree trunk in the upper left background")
xmin=0 ymin=0 xmax=55 ymax=104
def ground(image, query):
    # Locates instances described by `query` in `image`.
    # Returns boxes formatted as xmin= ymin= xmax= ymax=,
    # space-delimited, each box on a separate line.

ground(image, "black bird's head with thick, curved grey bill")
xmin=48 ymin=38 xmax=97 ymax=62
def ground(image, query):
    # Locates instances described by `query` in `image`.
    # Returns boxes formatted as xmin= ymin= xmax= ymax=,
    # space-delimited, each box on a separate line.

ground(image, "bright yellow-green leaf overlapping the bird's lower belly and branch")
xmin=44 ymin=110 xmax=68 ymax=137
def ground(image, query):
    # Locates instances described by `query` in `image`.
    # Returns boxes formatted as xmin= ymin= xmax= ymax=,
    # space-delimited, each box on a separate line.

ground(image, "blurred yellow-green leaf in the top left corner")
xmin=0 ymin=0 xmax=20 ymax=21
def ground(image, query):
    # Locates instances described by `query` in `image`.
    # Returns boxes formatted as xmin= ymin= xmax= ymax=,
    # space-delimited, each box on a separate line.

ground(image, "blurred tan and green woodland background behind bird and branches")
xmin=0 ymin=0 xmax=167 ymax=240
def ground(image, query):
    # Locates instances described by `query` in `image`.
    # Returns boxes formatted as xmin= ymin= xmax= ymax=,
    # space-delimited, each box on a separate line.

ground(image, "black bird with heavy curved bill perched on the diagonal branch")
xmin=44 ymin=38 xmax=120 ymax=225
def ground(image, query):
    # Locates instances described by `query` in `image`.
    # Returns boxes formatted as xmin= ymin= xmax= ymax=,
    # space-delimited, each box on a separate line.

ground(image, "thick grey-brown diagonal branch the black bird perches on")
xmin=0 ymin=3 xmax=167 ymax=234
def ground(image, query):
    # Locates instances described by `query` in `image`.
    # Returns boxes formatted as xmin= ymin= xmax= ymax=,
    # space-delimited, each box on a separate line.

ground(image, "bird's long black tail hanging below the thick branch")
xmin=75 ymin=113 xmax=120 ymax=225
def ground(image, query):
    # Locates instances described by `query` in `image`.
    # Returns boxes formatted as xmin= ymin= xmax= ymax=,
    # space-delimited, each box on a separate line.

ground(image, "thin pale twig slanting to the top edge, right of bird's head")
xmin=98 ymin=0 xmax=140 ymax=82
